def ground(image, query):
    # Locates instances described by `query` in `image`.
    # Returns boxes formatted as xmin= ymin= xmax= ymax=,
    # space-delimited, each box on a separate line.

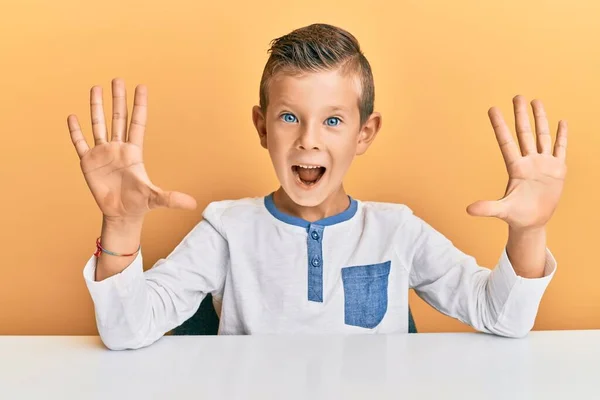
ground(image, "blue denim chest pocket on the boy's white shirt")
xmin=342 ymin=261 xmax=392 ymax=328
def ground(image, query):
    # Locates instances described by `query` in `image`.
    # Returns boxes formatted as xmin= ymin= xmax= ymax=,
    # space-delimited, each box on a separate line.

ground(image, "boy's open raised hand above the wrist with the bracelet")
xmin=67 ymin=79 xmax=196 ymax=222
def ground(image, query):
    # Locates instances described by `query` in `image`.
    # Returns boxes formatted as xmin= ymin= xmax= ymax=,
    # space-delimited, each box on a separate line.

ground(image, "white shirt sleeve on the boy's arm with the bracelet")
xmin=83 ymin=205 xmax=229 ymax=350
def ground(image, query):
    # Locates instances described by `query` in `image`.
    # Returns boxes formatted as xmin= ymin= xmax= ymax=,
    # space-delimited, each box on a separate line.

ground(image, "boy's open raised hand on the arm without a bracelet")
xmin=467 ymin=96 xmax=567 ymax=230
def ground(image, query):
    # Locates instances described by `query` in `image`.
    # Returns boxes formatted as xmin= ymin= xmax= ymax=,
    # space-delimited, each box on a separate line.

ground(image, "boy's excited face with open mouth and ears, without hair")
xmin=253 ymin=70 xmax=381 ymax=207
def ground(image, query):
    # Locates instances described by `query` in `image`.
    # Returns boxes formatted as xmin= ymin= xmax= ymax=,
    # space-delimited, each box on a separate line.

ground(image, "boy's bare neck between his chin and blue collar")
xmin=273 ymin=185 xmax=350 ymax=222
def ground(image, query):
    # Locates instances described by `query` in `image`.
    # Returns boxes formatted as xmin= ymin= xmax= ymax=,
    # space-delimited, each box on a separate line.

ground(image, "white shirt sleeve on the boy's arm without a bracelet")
xmin=397 ymin=214 xmax=556 ymax=337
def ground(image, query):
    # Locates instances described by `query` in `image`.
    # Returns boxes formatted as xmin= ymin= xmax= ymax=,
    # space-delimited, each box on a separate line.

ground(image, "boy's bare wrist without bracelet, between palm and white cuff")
xmin=506 ymin=227 xmax=546 ymax=278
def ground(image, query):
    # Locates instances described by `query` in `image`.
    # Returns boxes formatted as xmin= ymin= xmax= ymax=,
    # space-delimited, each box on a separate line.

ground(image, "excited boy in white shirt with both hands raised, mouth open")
xmin=68 ymin=24 xmax=567 ymax=349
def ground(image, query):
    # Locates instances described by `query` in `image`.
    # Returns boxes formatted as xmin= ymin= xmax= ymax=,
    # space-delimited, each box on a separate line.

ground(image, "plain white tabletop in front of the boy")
xmin=0 ymin=331 xmax=600 ymax=400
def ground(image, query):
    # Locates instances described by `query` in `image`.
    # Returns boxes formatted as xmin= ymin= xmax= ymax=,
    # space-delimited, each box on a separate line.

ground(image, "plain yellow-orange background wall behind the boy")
xmin=0 ymin=0 xmax=600 ymax=334
